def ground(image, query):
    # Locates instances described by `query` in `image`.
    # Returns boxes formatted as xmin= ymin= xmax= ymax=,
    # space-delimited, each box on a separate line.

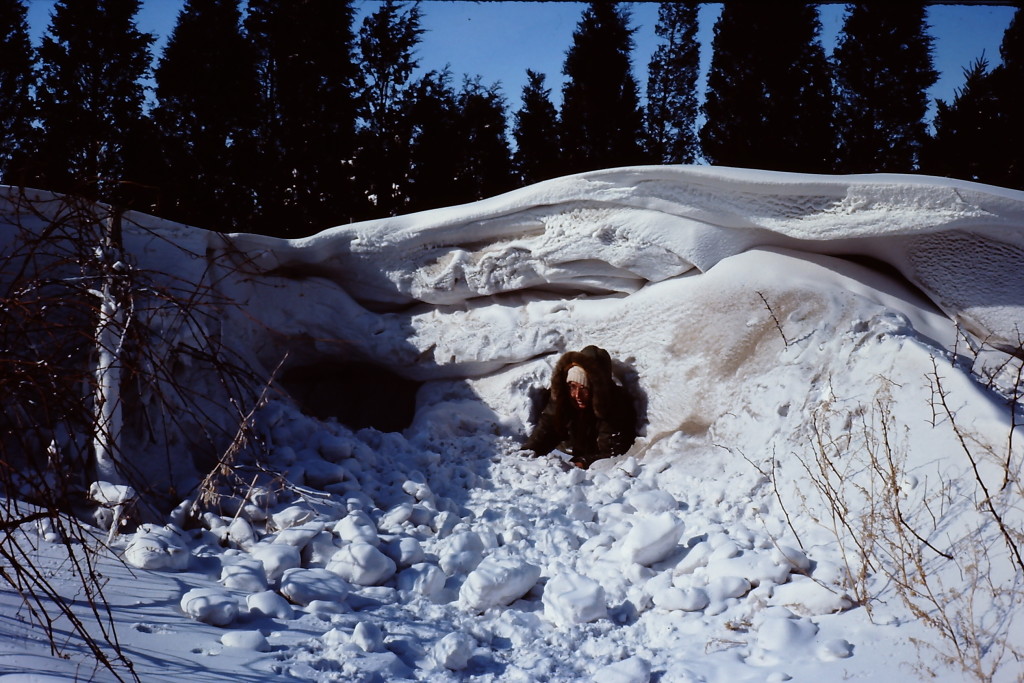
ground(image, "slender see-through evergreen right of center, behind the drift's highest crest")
xmin=646 ymin=2 xmax=699 ymax=164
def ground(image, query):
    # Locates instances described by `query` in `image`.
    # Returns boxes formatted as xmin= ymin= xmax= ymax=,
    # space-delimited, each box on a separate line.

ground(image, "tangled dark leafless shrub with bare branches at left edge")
xmin=0 ymin=185 xmax=268 ymax=679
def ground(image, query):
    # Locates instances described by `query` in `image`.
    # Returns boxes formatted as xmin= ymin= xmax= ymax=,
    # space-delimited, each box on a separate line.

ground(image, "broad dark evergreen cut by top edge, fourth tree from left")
xmin=245 ymin=0 xmax=357 ymax=237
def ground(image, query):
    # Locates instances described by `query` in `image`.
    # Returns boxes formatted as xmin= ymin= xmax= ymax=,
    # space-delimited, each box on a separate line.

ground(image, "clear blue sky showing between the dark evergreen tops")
xmin=29 ymin=0 xmax=1015 ymax=120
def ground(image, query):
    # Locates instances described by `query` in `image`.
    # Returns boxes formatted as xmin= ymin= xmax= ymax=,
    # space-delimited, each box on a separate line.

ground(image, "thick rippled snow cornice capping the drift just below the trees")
xmin=203 ymin=166 xmax=1024 ymax=365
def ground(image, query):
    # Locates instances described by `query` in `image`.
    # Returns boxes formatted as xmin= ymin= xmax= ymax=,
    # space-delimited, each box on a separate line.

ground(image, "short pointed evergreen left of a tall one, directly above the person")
xmin=512 ymin=70 xmax=561 ymax=185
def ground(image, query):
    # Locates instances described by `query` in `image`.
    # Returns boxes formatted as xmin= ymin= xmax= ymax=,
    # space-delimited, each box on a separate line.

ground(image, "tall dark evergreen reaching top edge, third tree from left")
xmin=154 ymin=0 xmax=258 ymax=230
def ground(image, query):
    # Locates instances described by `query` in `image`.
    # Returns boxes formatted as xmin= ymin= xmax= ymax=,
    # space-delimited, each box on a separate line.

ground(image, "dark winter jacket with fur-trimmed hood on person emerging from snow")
xmin=523 ymin=346 xmax=637 ymax=468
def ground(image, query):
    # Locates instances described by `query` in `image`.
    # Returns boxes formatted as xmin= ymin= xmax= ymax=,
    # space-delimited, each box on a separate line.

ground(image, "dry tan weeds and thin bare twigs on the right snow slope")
xmin=776 ymin=365 xmax=1024 ymax=681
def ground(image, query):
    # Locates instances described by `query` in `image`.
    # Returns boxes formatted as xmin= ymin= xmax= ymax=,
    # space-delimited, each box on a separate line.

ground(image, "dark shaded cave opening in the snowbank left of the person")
xmin=280 ymin=361 xmax=422 ymax=432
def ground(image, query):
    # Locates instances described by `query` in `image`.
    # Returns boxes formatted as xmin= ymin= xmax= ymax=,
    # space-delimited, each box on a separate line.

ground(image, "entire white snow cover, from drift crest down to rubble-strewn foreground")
xmin=0 ymin=167 xmax=1024 ymax=682
